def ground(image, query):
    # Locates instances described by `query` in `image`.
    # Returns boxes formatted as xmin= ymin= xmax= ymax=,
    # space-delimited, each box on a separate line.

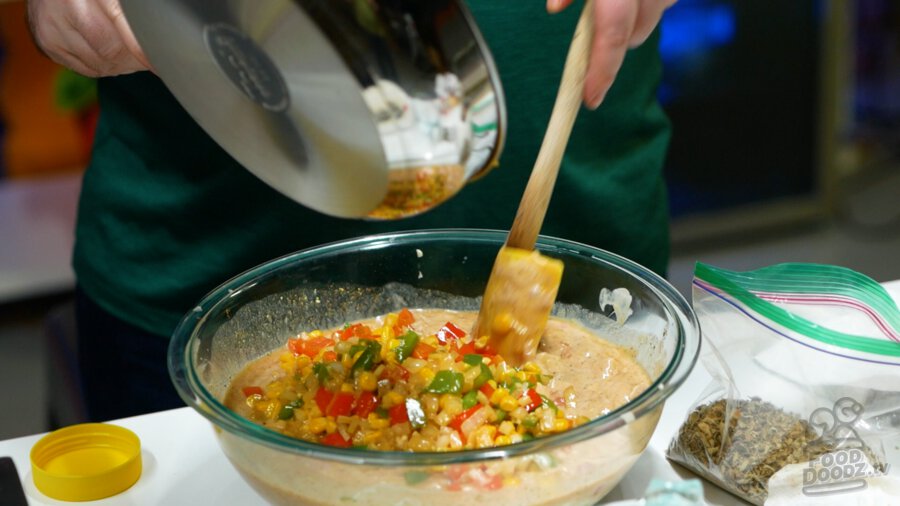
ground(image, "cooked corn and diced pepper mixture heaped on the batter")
xmin=232 ymin=309 xmax=588 ymax=451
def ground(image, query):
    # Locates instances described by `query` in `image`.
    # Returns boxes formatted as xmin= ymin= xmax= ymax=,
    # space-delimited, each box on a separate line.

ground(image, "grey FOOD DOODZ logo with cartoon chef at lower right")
xmin=802 ymin=397 xmax=889 ymax=496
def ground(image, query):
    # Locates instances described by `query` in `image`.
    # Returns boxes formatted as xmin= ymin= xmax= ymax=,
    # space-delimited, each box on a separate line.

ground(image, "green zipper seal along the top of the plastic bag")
xmin=694 ymin=262 xmax=900 ymax=357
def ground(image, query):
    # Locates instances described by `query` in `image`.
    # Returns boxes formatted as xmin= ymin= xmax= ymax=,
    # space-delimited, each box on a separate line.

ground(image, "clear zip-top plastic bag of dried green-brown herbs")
xmin=667 ymin=263 xmax=900 ymax=505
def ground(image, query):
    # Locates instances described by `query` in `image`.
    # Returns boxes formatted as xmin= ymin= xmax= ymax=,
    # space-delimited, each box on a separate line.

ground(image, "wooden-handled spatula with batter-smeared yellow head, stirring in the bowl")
xmin=475 ymin=0 xmax=593 ymax=366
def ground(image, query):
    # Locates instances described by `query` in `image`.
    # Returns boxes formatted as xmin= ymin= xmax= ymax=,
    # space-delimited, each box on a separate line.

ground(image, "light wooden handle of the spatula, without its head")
xmin=506 ymin=0 xmax=594 ymax=249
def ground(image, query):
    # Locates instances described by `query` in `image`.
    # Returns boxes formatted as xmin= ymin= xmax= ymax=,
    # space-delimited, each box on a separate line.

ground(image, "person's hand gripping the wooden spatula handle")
xmin=547 ymin=0 xmax=675 ymax=109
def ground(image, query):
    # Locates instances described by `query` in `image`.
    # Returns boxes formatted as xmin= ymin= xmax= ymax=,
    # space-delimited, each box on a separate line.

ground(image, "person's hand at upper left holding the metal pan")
xmin=28 ymin=0 xmax=150 ymax=77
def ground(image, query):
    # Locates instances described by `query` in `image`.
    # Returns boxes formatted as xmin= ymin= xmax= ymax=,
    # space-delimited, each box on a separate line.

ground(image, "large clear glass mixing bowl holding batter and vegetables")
xmin=169 ymin=230 xmax=700 ymax=506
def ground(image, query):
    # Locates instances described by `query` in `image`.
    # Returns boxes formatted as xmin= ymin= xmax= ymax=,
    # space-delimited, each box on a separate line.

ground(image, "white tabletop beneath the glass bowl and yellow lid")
xmin=0 ymin=280 xmax=900 ymax=506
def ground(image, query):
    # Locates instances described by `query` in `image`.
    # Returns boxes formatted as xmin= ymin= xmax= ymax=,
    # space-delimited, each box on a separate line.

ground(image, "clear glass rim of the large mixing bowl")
xmin=167 ymin=228 xmax=701 ymax=466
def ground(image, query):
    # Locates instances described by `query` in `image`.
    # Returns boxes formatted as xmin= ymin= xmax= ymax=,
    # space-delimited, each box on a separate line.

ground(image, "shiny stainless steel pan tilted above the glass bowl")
xmin=122 ymin=0 xmax=506 ymax=219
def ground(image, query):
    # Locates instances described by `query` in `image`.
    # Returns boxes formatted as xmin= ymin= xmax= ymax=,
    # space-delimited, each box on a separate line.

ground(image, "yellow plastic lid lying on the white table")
xmin=31 ymin=423 xmax=141 ymax=501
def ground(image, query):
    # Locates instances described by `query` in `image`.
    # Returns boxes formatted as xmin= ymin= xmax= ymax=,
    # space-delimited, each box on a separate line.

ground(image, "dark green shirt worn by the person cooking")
xmin=73 ymin=0 xmax=669 ymax=336
